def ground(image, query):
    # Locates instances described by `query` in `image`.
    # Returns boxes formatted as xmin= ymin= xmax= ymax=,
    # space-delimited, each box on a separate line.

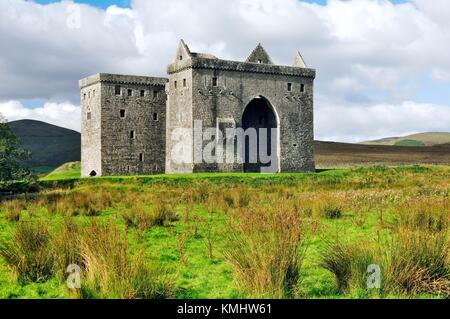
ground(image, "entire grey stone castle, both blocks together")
xmin=79 ymin=40 xmax=316 ymax=177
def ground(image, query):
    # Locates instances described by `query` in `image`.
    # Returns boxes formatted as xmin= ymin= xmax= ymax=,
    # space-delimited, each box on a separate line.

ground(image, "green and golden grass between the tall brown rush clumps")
xmin=0 ymin=165 xmax=450 ymax=298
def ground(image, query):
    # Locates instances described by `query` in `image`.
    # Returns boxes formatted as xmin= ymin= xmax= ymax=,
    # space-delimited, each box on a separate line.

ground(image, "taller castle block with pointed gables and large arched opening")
xmin=166 ymin=40 xmax=316 ymax=173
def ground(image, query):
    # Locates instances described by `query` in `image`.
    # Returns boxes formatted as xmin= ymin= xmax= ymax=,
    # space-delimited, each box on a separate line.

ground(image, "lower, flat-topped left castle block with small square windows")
xmin=81 ymin=74 xmax=167 ymax=176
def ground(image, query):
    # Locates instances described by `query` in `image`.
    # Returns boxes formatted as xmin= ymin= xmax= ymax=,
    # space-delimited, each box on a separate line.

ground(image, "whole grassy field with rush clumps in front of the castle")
xmin=0 ymin=166 xmax=450 ymax=298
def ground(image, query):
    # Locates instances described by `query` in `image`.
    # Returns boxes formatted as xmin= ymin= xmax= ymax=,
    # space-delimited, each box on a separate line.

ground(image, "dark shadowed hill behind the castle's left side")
xmin=8 ymin=120 xmax=81 ymax=168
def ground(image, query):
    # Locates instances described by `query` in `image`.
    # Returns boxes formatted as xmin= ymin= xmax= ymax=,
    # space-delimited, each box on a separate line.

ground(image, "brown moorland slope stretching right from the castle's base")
xmin=315 ymin=142 xmax=450 ymax=168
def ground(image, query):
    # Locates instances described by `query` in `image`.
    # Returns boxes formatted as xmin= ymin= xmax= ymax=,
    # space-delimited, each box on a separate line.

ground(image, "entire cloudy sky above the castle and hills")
xmin=0 ymin=0 xmax=450 ymax=142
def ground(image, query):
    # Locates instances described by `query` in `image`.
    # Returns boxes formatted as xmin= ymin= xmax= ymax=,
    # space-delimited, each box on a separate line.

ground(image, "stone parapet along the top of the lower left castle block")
xmin=78 ymin=73 xmax=167 ymax=89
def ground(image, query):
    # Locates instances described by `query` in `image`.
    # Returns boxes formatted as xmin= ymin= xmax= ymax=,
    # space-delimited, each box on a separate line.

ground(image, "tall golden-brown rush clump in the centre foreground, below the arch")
xmin=224 ymin=206 xmax=302 ymax=298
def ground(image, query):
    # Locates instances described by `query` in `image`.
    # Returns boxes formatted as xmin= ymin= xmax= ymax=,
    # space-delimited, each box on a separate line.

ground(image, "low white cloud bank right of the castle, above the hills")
xmin=315 ymin=100 xmax=450 ymax=142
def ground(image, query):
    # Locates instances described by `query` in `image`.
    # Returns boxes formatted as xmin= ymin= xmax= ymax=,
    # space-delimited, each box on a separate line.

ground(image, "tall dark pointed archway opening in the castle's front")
xmin=241 ymin=97 xmax=279 ymax=173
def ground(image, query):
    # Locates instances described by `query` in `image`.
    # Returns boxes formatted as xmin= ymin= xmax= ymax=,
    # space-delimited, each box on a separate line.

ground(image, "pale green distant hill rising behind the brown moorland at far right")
xmin=359 ymin=132 xmax=450 ymax=146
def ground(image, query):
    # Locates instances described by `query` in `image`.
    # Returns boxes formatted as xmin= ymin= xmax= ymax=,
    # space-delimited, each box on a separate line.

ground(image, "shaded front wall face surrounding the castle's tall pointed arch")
xmin=193 ymin=69 xmax=314 ymax=172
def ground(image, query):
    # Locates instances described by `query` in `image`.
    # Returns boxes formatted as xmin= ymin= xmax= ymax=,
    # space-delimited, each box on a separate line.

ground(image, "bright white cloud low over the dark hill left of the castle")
xmin=0 ymin=101 xmax=81 ymax=132
